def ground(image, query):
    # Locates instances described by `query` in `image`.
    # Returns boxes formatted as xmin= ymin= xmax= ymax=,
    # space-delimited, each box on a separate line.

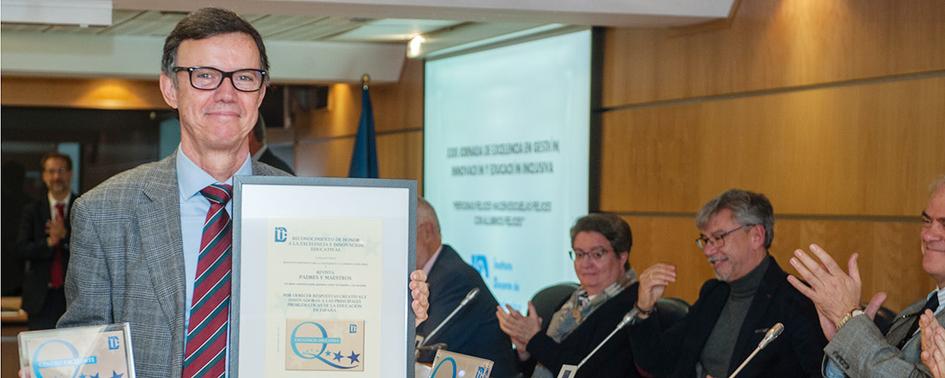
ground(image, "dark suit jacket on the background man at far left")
xmin=16 ymin=193 xmax=78 ymax=313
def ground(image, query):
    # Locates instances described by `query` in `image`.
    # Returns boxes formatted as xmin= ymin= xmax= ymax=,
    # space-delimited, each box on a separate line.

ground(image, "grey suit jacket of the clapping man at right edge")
xmin=824 ymin=298 xmax=945 ymax=377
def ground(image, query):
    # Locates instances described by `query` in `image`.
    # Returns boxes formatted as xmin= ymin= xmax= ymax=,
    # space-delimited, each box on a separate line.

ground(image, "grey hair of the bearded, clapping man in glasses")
xmin=696 ymin=189 xmax=774 ymax=249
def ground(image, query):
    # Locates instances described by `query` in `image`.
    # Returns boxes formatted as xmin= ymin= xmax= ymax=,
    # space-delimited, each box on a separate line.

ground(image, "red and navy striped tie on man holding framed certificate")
xmin=183 ymin=184 xmax=233 ymax=378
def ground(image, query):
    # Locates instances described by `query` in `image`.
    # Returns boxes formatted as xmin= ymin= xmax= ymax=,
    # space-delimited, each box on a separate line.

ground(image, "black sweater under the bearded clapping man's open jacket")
xmin=699 ymin=256 xmax=771 ymax=377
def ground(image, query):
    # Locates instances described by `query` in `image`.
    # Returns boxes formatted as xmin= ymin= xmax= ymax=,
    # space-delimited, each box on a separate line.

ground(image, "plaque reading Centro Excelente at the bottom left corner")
xmin=17 ymin=323 xmax=135 ymax=378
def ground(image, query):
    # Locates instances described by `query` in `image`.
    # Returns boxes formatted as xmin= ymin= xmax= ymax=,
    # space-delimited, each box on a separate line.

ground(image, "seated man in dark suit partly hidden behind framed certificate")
xmin=417 ymin=198 xmax=517 ymax=378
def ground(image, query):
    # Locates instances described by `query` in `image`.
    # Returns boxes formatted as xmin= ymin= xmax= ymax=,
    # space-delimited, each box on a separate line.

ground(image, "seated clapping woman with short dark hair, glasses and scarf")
xmin=496 ymin=214 xmax=638 ymax=378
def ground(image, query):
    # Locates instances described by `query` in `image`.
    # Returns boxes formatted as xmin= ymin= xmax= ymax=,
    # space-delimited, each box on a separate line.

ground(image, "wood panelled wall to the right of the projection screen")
xmin=599 ymin=0 xmax=945 ymax=310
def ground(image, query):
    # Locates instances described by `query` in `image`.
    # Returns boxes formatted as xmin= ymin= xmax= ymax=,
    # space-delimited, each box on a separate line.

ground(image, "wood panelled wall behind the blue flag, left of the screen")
xmin=294 ymin=60 xmax=423 ymax=187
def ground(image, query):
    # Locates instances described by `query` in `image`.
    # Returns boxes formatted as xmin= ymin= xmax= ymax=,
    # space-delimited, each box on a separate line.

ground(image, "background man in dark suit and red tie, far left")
xmin=17 ymin=152 xmax=76 ymax=329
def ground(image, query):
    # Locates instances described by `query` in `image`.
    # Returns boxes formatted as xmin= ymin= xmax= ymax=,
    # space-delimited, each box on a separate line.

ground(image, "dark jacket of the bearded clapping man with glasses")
xmin=629 ymin=257 xmax=827 ymax=377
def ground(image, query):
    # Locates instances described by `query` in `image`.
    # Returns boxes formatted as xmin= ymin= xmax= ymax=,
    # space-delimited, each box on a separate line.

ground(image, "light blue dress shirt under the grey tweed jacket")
xmin=177 ymin=147 xmax=253 ymax=371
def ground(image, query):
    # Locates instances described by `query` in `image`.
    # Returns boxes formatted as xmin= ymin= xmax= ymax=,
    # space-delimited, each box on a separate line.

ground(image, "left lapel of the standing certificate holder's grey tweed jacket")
xmin=136 ymin=155 xmax=185 ymax=358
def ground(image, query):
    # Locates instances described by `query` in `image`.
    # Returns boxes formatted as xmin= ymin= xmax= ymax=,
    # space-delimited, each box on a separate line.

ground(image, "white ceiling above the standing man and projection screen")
xmin=0 ymin=0 xmax=734 ymax=83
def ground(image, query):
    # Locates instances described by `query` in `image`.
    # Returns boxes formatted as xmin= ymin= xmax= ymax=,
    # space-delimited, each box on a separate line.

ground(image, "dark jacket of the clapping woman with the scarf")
xmin=523 ymin=283 xmax=639 ymax=378
